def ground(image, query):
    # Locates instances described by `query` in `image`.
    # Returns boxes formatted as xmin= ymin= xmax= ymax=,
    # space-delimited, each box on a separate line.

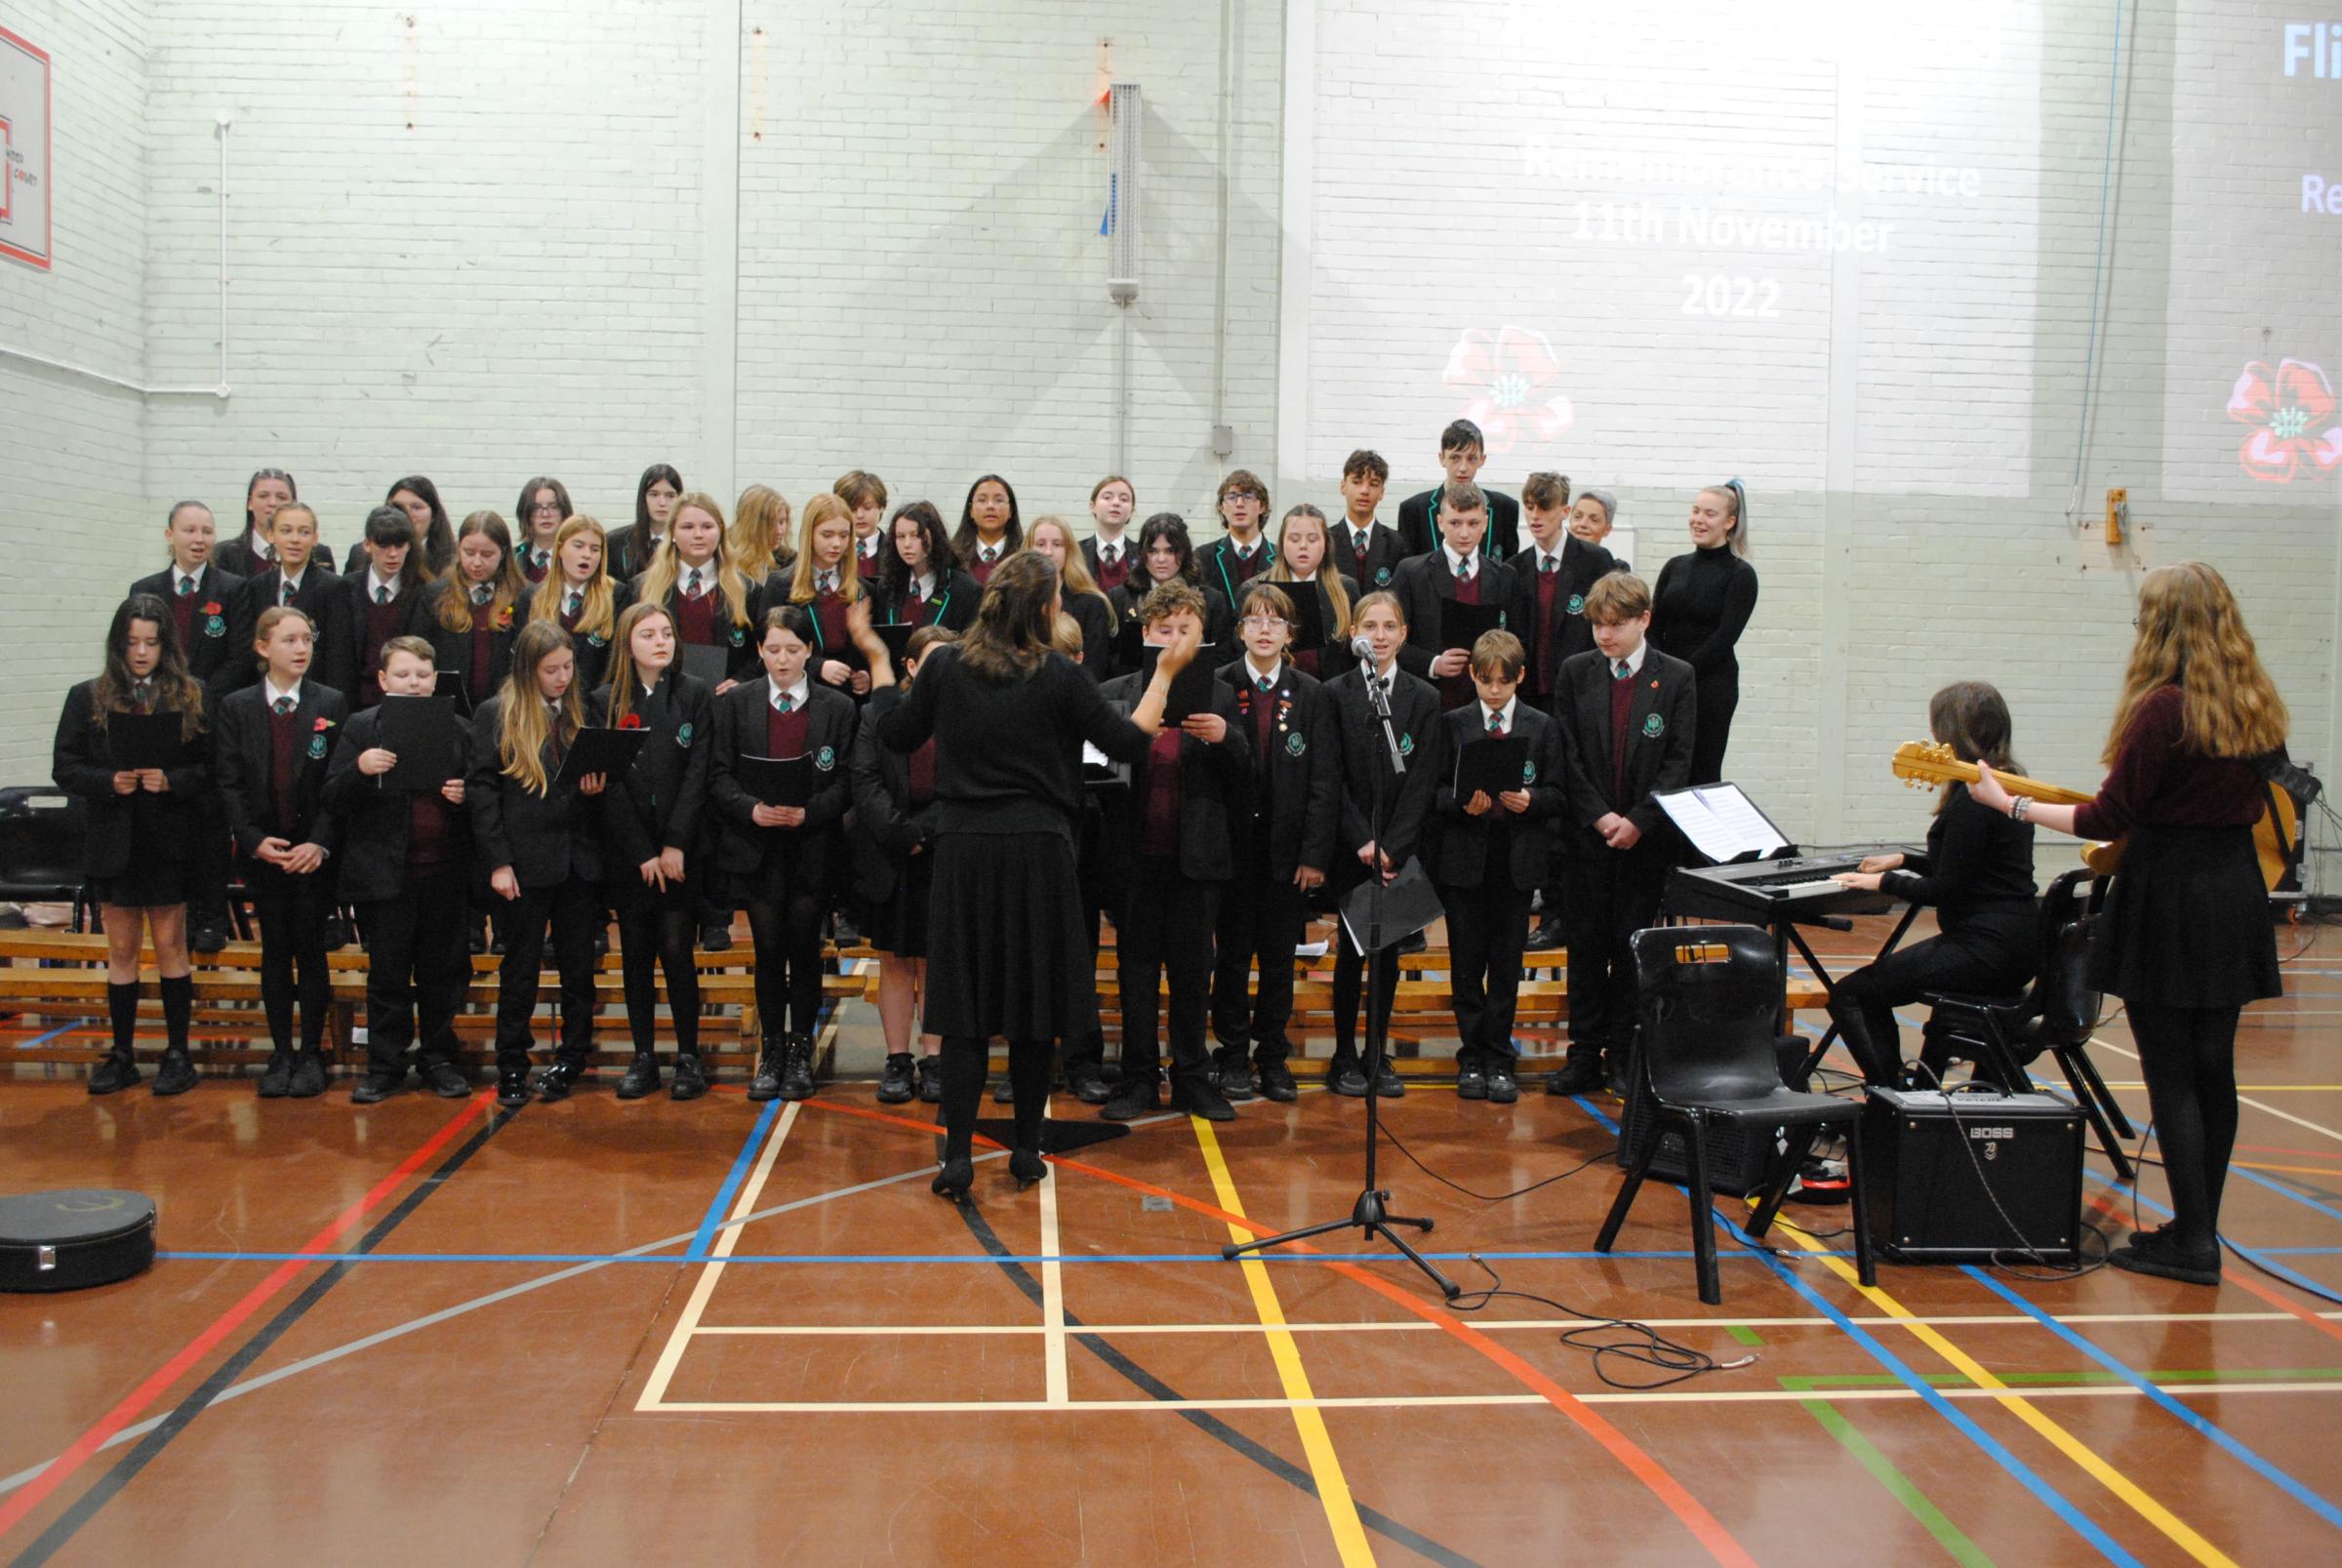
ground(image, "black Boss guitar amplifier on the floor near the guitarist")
xmin=1862 ymin=1088 xmax=2084 ymax=1264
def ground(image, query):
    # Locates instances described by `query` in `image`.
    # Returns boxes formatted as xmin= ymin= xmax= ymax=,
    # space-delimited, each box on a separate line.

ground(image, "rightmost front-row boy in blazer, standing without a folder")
xmin=1546 ymin=571 xmax=1696 ymax=1096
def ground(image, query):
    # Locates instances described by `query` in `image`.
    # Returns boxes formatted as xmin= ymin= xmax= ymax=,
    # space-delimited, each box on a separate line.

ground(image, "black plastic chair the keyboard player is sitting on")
xmin=1920 ymin=868 xmax=2138 ymax=1182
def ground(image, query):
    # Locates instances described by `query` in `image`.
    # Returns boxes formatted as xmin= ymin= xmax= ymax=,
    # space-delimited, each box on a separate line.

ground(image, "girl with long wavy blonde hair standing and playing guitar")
xmin=1972 ymin=562 xmax=2285 ymax=1285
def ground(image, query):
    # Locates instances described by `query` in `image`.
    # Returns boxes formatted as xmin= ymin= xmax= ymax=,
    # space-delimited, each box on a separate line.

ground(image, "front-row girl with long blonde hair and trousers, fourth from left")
xmin=466 ymin=621 xmax=604 ymax=1105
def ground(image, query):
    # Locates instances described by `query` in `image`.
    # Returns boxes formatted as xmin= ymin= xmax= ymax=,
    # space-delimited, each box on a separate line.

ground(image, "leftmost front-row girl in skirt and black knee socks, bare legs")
xmin=52 ymin=594 xmax=211 ymax=1096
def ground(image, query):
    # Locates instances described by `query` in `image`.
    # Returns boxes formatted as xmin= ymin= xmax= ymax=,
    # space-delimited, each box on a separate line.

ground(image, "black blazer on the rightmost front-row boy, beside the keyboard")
xmin=1553 ymin=644 xmax=1698 ymax=850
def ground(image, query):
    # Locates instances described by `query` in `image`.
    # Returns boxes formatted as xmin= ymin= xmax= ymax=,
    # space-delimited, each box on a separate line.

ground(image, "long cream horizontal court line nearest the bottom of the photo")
xmin=636 ymin=1381 xmax=2342 ymax=1416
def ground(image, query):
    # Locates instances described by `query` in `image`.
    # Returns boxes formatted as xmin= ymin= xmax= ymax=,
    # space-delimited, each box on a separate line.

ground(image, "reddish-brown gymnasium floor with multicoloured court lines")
xmin=0 ymin=932 xmax=2342 ymax=1566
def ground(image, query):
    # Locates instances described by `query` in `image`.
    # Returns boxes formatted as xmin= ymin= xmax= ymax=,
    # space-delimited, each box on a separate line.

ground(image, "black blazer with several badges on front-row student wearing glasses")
xmin=1220 ymin=658 xmax=1342 ymax=882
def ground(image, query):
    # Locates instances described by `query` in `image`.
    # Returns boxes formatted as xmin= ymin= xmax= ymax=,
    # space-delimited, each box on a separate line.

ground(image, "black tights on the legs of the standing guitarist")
xmin=2129 ymin=1002 xmax=2239 ymax=1252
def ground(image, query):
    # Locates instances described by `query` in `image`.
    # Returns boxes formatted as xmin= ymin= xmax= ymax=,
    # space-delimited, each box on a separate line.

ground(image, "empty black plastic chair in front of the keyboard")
xmin=1595 ymin=924 xmax=1878 ymax=1306
